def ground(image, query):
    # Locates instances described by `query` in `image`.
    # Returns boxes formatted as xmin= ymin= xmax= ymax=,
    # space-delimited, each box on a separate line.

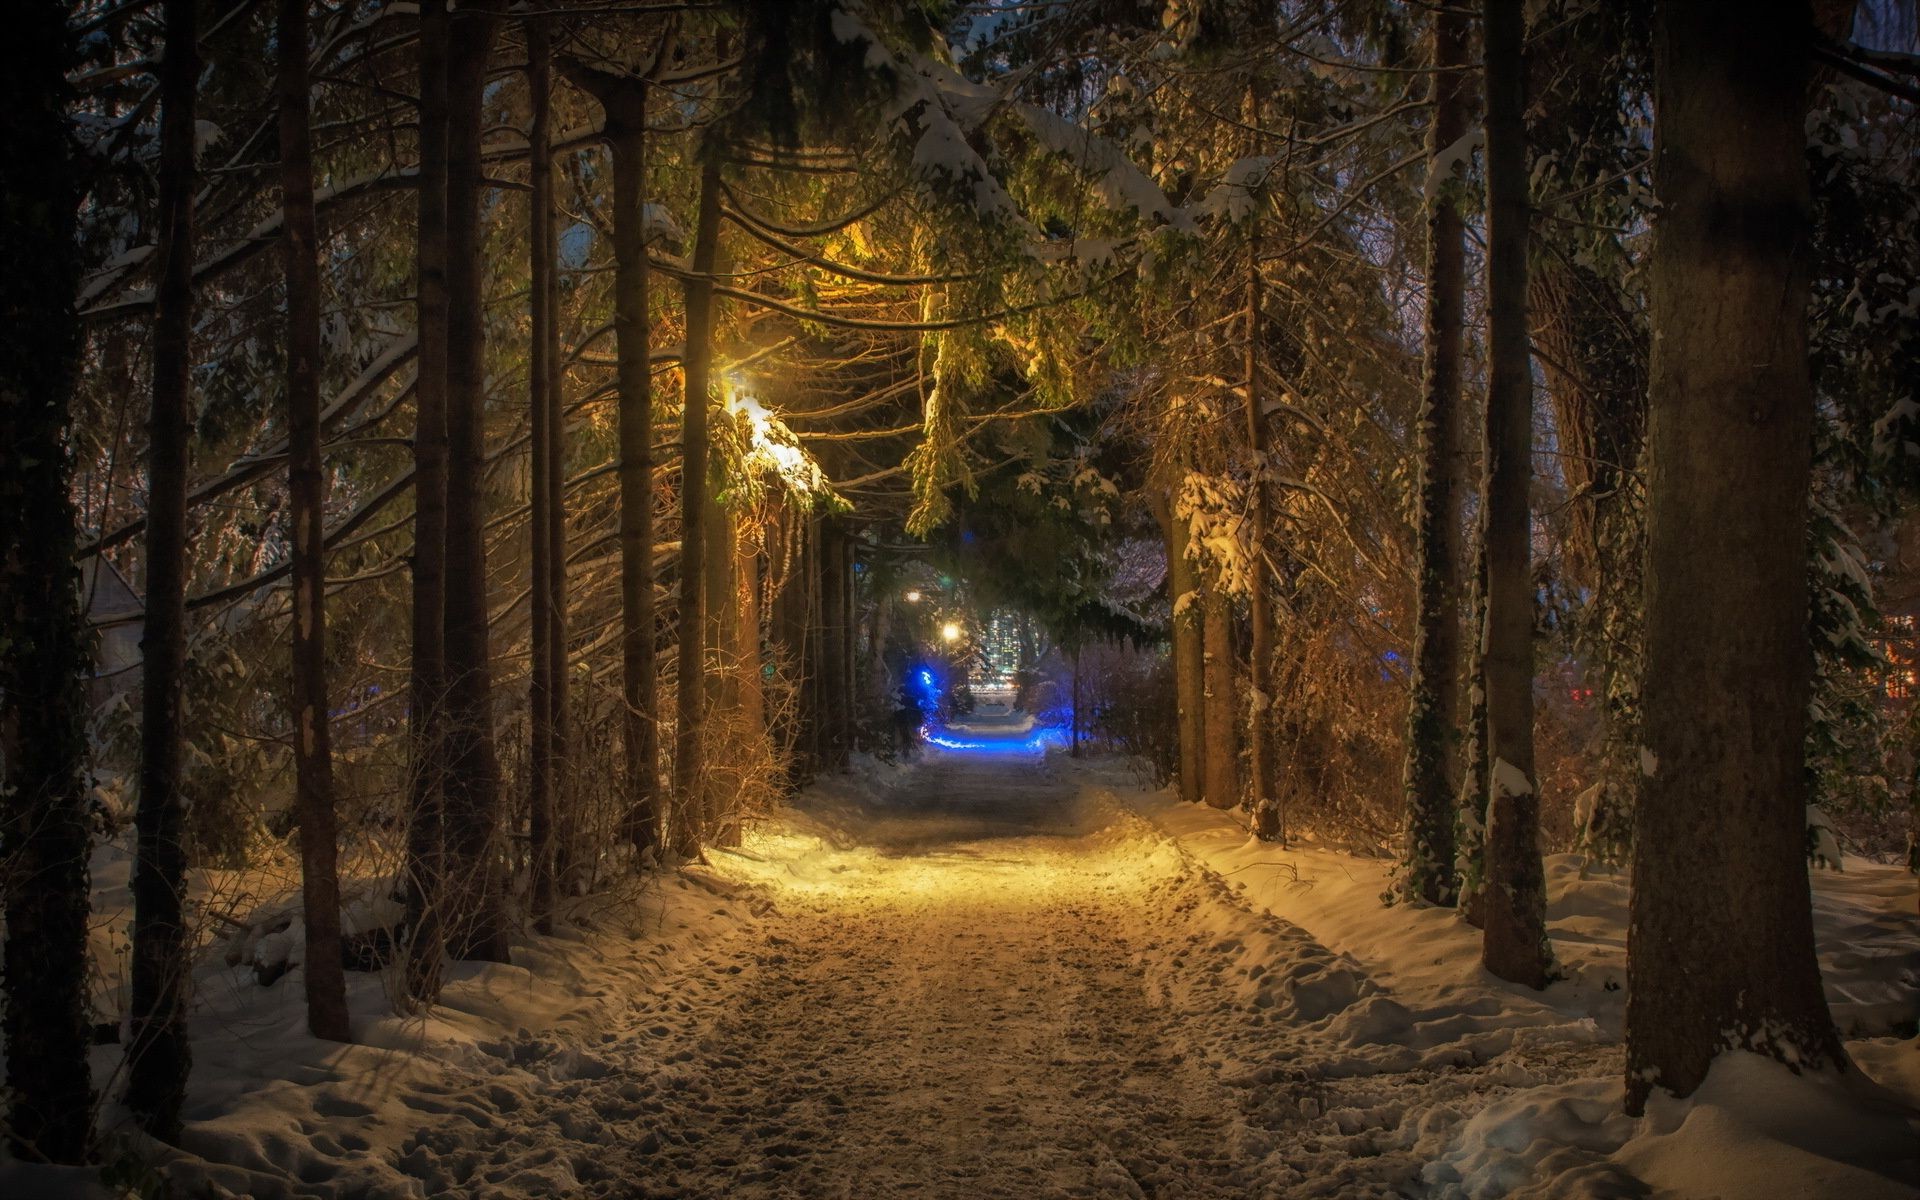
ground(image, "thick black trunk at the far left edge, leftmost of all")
xmin=0 ymin=0 xmax=94 ymax=1164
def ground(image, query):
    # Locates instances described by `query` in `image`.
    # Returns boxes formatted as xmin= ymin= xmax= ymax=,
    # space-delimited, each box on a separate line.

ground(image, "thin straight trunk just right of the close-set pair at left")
xmin=520 ymin=15 xmax=564 ymax=933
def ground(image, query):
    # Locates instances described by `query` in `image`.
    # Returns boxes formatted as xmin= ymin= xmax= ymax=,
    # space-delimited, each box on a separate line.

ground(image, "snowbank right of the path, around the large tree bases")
xmin=1094 ymin=768 xmax=1920 ymax=1200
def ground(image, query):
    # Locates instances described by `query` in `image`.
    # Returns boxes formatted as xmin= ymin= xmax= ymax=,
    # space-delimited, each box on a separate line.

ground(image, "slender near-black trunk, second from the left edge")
xmin=127 ymin=0 xmax=200 ymax=1142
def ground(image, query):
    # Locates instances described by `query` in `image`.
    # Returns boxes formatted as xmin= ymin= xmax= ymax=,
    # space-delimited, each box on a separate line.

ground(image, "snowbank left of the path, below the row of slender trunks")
xmin=0 ymin=849 xmax=766 ymax=1200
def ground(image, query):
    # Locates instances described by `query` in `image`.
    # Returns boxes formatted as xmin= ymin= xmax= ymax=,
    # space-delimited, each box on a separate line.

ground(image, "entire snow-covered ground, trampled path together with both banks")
xmin=0 ymin=744 xmax=1920 ymax=1198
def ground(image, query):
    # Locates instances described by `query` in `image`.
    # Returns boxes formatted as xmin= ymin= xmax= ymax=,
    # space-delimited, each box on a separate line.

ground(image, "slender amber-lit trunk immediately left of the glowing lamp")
xmin=674 ymin=138 xmax=720 ymax=858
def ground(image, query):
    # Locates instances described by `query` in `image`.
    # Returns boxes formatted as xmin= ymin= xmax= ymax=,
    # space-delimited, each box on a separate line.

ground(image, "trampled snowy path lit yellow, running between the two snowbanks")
xmin=378 ymin=756 xmax=1620 ymax=1198
